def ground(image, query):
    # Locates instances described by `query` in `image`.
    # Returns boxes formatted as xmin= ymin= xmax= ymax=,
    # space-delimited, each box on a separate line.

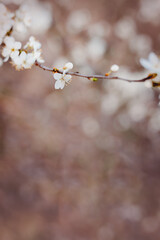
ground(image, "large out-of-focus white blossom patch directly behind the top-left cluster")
xmin=13 ymin=0 xmax=53 ymax=40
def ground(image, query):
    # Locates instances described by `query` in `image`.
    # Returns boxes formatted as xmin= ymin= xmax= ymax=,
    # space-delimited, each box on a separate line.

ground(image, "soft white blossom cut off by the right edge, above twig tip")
xmin=140 ymin=52 xmax=160 ymax=74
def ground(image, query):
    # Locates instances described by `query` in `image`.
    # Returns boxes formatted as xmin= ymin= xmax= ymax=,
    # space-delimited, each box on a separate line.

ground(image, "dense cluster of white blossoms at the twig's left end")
xmin=0 ymin=3 xmax=44 ymax=70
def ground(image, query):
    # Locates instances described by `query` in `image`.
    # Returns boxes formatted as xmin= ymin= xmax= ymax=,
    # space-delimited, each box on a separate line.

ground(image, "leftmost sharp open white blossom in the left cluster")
xmin=2 ymin=36 xmax=22 ymax=62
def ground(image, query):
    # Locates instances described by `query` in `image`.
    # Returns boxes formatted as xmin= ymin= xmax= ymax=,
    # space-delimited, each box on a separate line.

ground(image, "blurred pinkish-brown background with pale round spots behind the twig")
xmin=0 ymin=0 xmax=160 ymax=240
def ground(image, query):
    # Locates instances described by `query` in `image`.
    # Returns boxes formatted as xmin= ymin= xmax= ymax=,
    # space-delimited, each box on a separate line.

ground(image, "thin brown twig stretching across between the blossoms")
xmin=35 ymin=61 xmax=157 ymax=83
